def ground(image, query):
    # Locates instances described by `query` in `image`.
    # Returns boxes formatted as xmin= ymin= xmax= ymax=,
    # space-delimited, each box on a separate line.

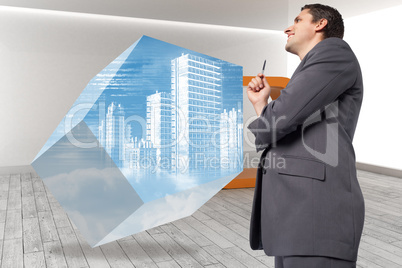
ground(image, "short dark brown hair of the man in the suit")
xmin=301 ymin=4 xmax=345 ymax=39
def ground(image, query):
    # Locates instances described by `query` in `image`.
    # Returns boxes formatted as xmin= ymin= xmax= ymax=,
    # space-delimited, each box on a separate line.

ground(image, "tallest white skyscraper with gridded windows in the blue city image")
xmin=171 ymin=54 xmax=222 ymax=172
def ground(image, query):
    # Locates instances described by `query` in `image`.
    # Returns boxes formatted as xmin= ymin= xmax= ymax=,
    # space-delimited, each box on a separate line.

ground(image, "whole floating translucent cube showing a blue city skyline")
xmin=32 ymin=36 xmax=243 ymax=247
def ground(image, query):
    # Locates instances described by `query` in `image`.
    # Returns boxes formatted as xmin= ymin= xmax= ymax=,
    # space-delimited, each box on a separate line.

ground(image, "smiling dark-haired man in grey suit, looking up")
xmin=247 ymin=4 xmax=364 ymax=268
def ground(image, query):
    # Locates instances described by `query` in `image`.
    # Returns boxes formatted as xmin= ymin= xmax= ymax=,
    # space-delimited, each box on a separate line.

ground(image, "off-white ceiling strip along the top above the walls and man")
xmin=0 ymin=0 xmax=402 ymax=31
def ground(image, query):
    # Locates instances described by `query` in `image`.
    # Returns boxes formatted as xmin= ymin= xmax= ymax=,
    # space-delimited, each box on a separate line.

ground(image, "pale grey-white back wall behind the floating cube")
xmin=0 ymin=6 xmax=286 ymax=167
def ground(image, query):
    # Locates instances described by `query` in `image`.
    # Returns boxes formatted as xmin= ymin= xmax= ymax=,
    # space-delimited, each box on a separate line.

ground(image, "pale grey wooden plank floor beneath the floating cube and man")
xmin=0 ymin=171 xmax=402 ymax=268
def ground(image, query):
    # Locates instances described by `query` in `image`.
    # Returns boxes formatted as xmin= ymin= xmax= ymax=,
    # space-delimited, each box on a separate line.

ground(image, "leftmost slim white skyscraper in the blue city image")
xmin=105 ymin=103 xmax=124 ymax=167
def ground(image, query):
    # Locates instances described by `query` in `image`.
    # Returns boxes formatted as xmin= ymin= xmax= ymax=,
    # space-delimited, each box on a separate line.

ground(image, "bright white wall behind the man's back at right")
xmin=288 ymin=5 xmax=402 ymax=170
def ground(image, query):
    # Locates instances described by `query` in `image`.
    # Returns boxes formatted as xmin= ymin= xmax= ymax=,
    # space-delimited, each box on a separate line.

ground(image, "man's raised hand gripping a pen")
xmin=247 ymin=73 xmax=271 ymax=116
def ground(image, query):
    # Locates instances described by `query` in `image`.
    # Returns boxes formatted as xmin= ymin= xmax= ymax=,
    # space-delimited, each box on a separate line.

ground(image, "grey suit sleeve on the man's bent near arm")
xmin=248 ymin=41 xmax=358 ymax=151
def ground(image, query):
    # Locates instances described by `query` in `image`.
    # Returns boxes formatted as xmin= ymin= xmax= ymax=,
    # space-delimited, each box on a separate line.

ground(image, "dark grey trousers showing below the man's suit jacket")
xmin=275 ymin=256 xmax=356 ymax=268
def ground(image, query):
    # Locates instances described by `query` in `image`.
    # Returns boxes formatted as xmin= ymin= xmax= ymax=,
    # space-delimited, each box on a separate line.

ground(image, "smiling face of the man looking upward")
xmin=285 ymin=9 xmax=316 ymax=55
